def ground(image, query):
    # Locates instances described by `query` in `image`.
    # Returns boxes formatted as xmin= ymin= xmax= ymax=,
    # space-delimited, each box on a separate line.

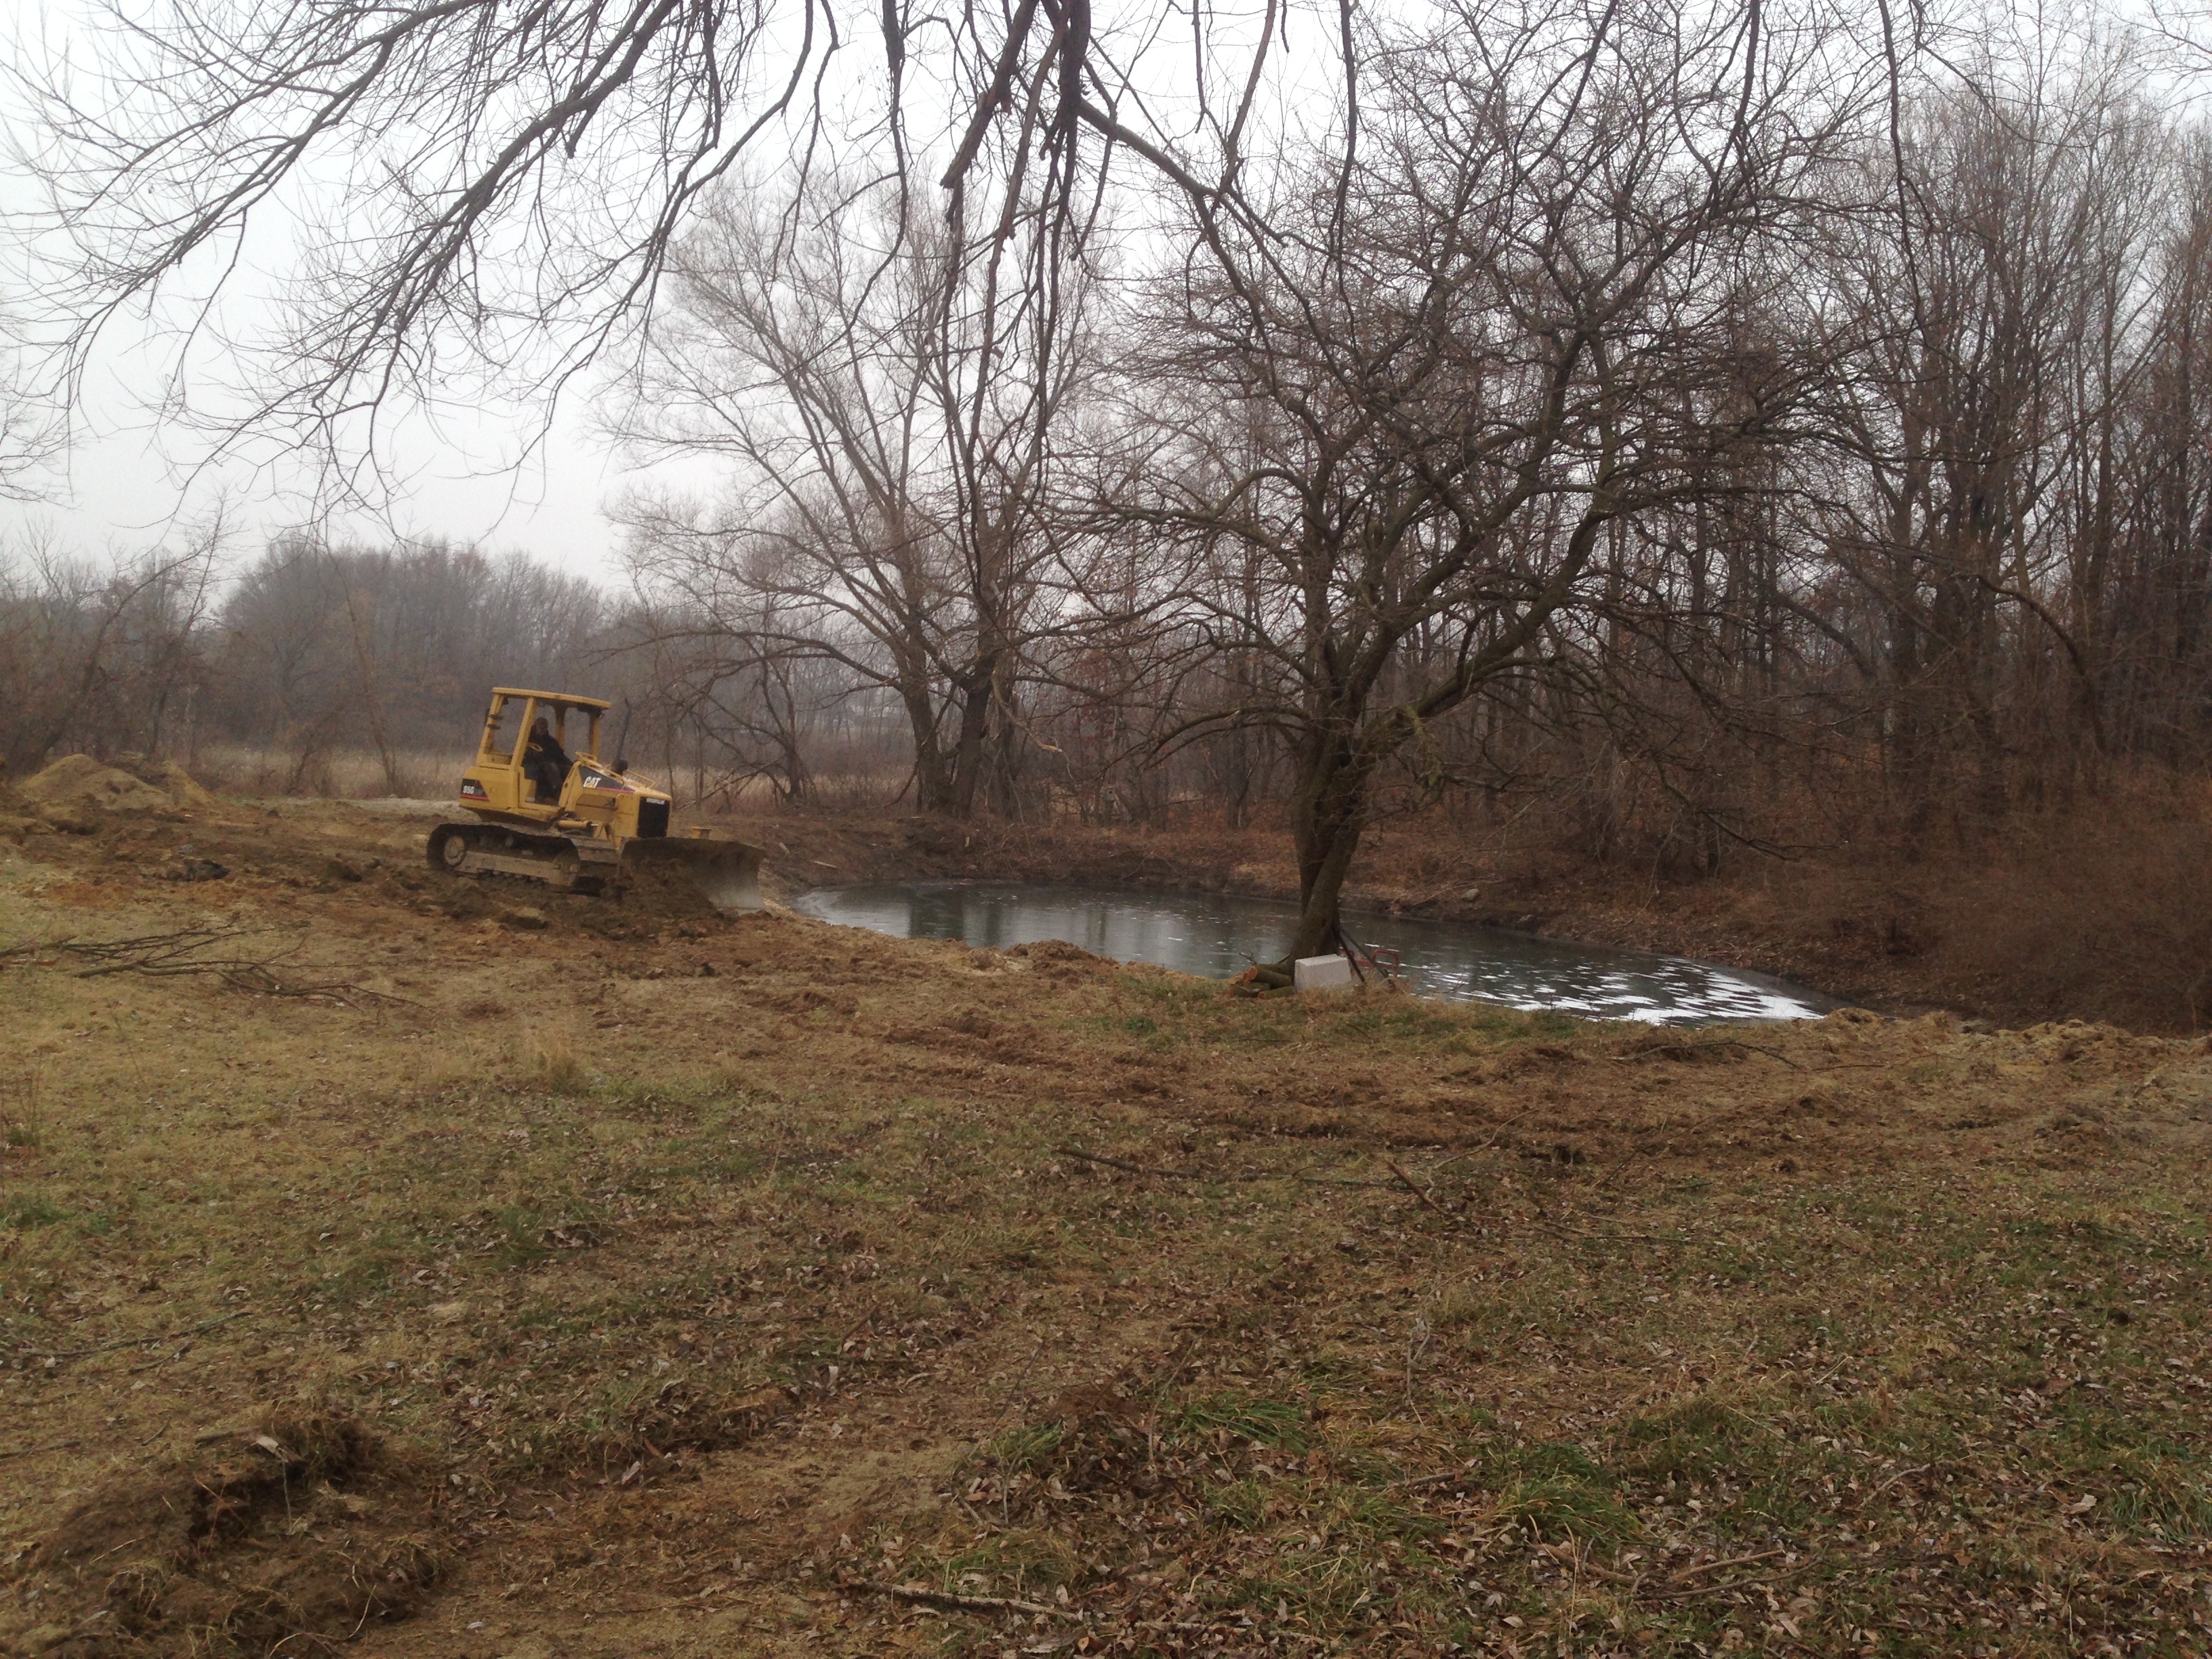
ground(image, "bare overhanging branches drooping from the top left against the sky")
xmin=16 ymin=0 xmax=1203 ymax=499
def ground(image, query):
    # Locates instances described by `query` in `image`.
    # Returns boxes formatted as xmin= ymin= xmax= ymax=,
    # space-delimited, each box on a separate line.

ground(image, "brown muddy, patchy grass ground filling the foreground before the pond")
xmin=0 ymin=803 xmax=2212 ymax=1659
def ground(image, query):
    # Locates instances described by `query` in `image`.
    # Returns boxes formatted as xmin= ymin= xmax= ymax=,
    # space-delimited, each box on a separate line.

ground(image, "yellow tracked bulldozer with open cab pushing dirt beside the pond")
xmin=429 ymin=686 xmax=761 ymax=912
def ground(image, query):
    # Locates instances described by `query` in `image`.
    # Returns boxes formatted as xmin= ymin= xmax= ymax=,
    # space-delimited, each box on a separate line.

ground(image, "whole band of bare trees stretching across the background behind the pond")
xmin=13 ymin=16 xmax=2212 ymax=947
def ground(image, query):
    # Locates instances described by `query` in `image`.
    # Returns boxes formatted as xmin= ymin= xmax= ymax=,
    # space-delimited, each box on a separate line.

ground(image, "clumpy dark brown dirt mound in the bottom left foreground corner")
xmin=0 ymin=1411 xmax=441 ymax=1659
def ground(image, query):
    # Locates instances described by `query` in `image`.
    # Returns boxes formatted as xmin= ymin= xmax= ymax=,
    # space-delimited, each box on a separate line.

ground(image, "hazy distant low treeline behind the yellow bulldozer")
xmin=0 ymin=533 xmax=903 ymax=798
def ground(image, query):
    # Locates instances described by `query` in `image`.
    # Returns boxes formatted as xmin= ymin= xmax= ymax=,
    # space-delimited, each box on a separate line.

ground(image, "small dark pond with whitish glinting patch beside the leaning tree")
xmin=794 ymin=882 xmax=1838 ymax=1024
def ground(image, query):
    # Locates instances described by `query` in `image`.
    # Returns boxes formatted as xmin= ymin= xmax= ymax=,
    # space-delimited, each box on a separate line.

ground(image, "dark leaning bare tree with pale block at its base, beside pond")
xmin=1130 ymin=0 xmax=1851 ymax=954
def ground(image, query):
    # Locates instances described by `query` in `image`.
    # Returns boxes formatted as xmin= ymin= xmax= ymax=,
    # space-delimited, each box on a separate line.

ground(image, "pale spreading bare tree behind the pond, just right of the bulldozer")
xmin=623 ymin=172 xmax=1092 ymax=816
